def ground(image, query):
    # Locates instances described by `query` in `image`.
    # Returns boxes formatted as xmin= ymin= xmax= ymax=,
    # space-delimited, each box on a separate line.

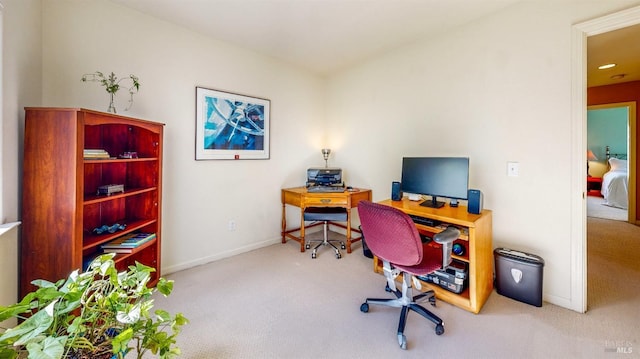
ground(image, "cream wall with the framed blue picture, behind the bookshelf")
xmin=43 ymin=0 xmax=324 ymax=272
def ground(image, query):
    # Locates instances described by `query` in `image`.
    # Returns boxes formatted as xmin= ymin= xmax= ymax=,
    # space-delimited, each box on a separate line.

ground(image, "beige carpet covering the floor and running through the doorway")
xmin=151 ymin=222 xmax=640 ymax=359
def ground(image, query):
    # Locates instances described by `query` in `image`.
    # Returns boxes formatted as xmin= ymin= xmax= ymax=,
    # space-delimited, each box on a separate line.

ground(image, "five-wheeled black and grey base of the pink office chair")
xmin=360 ymin=273 xmax=444 ymax=349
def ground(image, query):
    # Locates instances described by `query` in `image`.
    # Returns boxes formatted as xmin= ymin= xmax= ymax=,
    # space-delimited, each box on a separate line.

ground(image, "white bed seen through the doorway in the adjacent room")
xmin=601 ymin=157 xmax=629 ymax=209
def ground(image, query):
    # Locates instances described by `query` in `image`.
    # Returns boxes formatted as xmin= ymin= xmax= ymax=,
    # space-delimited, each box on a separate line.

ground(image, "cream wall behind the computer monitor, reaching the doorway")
xmin=327 ymin=2 xmax=636 ymax=307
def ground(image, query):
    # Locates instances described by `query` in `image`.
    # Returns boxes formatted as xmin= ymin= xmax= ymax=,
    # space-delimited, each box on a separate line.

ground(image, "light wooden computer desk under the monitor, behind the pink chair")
xmin=373 ymin=198 xmax=493 ymax=313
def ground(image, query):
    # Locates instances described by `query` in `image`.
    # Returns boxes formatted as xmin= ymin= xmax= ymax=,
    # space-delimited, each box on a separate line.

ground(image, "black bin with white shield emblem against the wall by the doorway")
xmin=493 ymin=248 xmax=544 ymax=307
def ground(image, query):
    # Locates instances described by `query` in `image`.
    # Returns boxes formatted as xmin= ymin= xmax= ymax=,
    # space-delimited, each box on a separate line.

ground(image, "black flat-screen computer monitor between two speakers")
xmin=402 ymin=157 xmax=469 ymax=208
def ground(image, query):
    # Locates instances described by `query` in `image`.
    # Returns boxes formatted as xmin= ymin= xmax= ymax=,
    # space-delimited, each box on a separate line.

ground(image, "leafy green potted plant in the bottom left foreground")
xmin=0 ymin=253 xmax=188 ymax=359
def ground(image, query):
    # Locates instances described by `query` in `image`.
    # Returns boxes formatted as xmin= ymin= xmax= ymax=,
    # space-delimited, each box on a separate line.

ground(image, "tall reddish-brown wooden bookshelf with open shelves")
xmin=20 ymin=107 xmax=164 ymax=297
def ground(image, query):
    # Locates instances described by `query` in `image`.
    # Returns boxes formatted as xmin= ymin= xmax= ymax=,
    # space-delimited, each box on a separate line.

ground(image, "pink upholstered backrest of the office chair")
xmin=358 ymin=201 xmax=423 ymax=266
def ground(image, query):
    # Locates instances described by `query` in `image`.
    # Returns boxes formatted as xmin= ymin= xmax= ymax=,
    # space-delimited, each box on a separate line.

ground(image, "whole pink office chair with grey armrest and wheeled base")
xmin=358 ymin=201 xmax=460 ymax=349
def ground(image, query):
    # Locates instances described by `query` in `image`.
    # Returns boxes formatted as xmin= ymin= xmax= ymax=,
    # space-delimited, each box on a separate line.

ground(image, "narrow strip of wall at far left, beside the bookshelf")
xmin=0 ymin=0 xmax=42 ymax=308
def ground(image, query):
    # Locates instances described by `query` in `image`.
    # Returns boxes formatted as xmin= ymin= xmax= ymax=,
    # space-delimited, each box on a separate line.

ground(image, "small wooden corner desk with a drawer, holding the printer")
xmin=282 ymin=187 xmax=371 ymax=253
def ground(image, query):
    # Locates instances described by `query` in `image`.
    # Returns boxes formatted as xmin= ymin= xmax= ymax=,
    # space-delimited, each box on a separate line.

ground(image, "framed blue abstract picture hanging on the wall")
xmin=196 ymin=87 xmax=271 ymax=160
